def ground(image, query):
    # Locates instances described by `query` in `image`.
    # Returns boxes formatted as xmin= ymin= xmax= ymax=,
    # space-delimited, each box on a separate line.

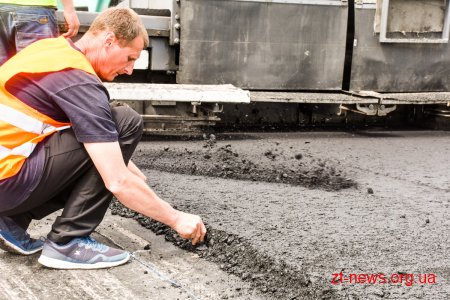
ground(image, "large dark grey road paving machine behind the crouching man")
xmin=59 ymin=0 xmax=450 ymax=131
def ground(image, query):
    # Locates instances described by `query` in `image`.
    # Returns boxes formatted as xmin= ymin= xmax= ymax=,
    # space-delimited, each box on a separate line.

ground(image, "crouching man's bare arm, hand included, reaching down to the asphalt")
xmin=84 ymin=142 xmax=206 ymax=245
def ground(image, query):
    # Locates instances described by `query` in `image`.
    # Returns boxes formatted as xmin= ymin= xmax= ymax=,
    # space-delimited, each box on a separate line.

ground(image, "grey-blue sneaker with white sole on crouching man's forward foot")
xmin=38 ymin=236 xmax=130 ymax=269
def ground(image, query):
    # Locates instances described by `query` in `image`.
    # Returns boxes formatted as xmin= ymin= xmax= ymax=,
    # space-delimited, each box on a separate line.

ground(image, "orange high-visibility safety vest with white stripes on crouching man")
xmin=0 ymin=37 xmax=97 ymax=180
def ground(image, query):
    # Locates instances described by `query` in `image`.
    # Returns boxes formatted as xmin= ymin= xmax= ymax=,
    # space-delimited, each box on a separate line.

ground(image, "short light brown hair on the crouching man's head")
xmin=87 ymin=7 xmax=150 ymax=48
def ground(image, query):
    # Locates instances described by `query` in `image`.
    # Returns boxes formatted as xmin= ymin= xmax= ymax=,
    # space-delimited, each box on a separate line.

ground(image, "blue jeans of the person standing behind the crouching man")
xmin=0 ymin=4 xmax=58 ymax=65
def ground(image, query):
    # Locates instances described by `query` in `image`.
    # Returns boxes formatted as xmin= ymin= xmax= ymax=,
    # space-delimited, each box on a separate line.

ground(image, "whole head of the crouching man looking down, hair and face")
xmin=80 ymin=7 xmax=149 ymax=81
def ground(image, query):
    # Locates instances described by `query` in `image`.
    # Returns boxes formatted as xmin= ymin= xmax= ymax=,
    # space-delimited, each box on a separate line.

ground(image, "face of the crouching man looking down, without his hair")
xmin=95 ymin=35 xmax=144 ymax=81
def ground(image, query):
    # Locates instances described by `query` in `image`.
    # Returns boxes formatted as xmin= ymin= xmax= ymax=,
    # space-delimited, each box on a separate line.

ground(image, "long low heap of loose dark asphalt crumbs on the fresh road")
xmin=136 ymin=134 xmax=356 ymax=190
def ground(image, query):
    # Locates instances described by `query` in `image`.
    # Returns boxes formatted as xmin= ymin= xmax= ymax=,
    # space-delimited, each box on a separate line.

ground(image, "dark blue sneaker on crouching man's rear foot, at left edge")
xmin=0 ymin=217 xmax=44 ymax=255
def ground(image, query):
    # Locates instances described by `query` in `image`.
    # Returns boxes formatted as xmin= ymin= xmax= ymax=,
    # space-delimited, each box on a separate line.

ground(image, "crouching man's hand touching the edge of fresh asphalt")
xmin=173 ymin=211 xmax=206 ymax=245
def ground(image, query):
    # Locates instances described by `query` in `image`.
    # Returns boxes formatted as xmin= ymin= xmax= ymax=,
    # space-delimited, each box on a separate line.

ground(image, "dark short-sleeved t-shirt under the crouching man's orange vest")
xmin=0 ymin=57 xmax=118 ymax=212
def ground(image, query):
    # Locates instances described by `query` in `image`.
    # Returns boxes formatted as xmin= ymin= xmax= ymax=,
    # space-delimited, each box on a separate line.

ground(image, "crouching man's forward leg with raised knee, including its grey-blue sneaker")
xmin=38 ymin=107 xmax=143 ymax=269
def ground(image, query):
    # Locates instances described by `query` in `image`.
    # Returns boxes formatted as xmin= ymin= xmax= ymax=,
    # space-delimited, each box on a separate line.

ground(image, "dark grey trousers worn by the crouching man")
xmin=6 ymin=106 xmax=143 ymax=244
